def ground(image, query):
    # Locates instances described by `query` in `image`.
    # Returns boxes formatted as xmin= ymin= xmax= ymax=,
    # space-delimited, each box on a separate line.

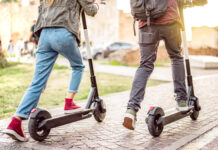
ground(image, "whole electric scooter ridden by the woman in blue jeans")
xmin=28 ymin=7 xmax=106 ymax=141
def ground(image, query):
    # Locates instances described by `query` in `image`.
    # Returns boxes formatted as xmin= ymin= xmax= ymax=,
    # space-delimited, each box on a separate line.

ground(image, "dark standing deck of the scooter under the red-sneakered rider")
xmin=38 ymin=109 xmax=93 ymax=129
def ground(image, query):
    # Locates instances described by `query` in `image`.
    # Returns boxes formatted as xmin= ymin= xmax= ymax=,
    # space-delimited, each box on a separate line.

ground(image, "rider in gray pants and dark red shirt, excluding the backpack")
xmin=123 ymin=0 xmax=188 ymax=130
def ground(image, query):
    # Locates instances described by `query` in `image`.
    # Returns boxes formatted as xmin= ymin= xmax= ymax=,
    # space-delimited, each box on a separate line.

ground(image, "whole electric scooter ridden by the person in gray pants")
xmin=145 ymin=6 xmax=201 ymax=137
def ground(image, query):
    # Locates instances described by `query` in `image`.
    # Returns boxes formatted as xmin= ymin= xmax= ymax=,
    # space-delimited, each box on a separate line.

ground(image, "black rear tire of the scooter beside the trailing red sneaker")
xmin=28 ymin=110 xmax=51 ymax=141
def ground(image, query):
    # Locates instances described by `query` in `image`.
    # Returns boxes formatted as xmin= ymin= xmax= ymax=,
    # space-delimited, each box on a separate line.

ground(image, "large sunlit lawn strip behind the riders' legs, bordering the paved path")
xmin=0 ymin=63 xmax=164 ymax=119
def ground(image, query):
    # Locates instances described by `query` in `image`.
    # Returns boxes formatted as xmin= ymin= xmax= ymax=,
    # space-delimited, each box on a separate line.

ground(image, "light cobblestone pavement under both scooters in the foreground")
xmin=0 ymin=75 xmax=218 ymax=150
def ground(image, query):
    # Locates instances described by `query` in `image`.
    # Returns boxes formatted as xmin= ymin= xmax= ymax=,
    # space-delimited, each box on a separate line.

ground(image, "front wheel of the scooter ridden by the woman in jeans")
xmin=93 ymin=100 xmax=106 ymax=122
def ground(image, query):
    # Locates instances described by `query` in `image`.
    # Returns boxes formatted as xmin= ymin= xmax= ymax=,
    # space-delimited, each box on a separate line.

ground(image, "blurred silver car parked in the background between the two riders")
xmin=81 ymin=41 xmax=138 ymax=59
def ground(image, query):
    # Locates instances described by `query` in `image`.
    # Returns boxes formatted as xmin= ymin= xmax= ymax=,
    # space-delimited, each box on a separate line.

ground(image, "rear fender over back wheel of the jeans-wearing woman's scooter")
xmin=30 ymin=108 xmax=51 ymax=119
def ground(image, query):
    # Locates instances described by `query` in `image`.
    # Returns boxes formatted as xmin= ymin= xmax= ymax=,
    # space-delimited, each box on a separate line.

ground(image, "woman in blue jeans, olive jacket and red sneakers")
xmin=5 ymin=0 xmax=100 ymax=141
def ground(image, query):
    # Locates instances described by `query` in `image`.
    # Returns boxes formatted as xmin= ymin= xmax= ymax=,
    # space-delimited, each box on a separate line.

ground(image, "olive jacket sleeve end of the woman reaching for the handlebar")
xmin=78 ymin=0 xmax=98 ymax=16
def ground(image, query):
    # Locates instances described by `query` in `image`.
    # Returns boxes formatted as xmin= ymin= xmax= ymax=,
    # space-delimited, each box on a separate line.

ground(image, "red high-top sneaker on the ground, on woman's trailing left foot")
xmin=5 ymin=117 xmax=28 ymax=142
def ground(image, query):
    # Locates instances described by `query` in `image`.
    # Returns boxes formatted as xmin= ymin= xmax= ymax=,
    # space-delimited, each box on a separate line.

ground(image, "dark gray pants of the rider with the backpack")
xmin=127 ymin=23 xmax=187 ymax=111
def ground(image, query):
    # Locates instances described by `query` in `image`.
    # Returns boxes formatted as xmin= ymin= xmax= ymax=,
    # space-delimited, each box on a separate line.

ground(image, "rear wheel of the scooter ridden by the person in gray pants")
xmin=147 ymin=115 xmax=163 ymax=137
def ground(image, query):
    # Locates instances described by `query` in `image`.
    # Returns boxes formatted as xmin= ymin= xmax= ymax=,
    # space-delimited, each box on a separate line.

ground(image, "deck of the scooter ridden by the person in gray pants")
xmin=162 ymin=106 xmax=194 ymax=125
